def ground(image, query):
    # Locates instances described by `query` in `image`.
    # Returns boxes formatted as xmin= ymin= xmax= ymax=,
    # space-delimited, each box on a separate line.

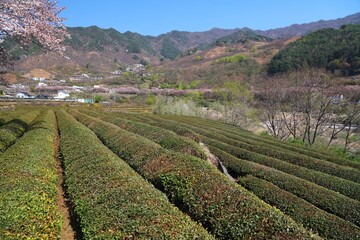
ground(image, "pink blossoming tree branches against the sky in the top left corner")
xmin=0 ymin=0 xmax=69 ymax=66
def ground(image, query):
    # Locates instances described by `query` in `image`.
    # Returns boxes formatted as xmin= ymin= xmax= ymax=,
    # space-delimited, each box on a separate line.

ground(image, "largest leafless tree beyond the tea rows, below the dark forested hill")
xmin=260 ymin=70 xmax=338 ymax=146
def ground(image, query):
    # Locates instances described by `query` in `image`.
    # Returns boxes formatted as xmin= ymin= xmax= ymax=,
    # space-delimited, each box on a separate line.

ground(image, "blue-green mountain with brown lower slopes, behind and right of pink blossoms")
xmin=5 ymin=26 xmax=242 ymax=72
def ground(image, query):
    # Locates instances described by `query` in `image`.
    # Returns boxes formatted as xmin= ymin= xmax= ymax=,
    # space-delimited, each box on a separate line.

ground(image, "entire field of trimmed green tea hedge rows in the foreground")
xmin=0 ymin=108 xmax=360 ymax=239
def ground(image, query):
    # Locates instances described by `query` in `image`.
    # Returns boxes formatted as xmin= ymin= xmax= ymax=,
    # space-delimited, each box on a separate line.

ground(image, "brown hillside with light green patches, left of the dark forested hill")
xmin=154 ymin=37 xmax=298 ymax=87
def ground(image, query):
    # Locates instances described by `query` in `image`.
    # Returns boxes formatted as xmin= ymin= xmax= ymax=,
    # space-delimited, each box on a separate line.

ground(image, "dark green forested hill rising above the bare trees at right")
xmin=268 ymin=25 xmax=360 ymax=75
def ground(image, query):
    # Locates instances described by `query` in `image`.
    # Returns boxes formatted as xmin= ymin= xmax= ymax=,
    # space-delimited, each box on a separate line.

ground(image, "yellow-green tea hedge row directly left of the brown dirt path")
xmin=0 ymin=111 xmax=62 ymax=239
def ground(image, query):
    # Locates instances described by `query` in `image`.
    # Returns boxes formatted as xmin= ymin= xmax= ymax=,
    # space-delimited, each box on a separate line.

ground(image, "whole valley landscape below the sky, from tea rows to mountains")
xmin=0 ymin=5 xmax=360 ymax=240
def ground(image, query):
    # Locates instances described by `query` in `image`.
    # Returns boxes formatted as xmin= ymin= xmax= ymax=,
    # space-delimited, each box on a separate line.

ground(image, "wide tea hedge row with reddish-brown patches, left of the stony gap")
xmin=71 ymin=111 xmax=316 ymax=239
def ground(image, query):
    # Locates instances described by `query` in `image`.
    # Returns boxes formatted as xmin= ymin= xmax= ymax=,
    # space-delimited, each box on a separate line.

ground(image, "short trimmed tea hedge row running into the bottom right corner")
xmin=239 ymin=175 xmax=360 ymax=240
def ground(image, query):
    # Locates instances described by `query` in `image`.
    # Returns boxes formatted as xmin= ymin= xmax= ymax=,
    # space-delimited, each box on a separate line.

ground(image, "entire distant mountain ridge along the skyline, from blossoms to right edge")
xmin=7 ymin=13 xmax=360 ymax=71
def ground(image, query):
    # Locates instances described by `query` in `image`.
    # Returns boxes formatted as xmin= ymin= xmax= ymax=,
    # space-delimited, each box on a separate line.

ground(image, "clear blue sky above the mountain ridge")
xmin=59 ymin=0 xmax=360 ymax=36
